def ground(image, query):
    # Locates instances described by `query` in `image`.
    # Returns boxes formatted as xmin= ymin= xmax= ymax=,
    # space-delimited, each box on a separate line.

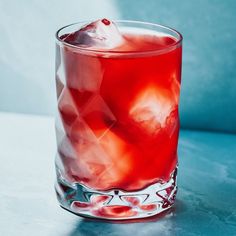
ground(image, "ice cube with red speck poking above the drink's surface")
xmin=63 ymin=19 xmax=124 ymax=50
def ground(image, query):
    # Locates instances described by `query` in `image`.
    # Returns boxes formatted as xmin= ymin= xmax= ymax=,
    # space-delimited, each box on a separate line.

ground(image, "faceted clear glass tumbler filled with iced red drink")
xmin=56 ymin=21 xmax=182 ymax=219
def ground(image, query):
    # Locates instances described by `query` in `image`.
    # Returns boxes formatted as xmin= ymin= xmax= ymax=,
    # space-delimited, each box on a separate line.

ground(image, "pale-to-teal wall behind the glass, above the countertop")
xmin=0 ymin=0 xmax=236 ymax=133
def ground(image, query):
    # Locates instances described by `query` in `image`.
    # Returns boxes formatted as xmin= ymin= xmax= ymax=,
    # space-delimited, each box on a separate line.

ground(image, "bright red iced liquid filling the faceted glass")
xmin=57 ymin=30 xmax=182 ymax=191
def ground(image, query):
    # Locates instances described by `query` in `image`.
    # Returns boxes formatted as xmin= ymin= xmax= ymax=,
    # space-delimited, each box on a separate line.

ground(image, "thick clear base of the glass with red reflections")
xmin=56 ymin=168 xmax=177 ymax=220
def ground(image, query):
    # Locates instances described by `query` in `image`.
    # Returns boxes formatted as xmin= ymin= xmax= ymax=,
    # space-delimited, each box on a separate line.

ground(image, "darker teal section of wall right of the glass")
xmin=116 ymin=0 xmax=236 ymax=132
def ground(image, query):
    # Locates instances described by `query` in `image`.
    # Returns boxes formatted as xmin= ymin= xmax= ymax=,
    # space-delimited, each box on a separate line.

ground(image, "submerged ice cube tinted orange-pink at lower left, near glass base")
xmin=70 ymin=127 xmax=132 ymax=189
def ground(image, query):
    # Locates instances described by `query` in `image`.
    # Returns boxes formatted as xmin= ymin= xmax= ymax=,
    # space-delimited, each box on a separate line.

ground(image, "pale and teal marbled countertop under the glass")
xmin=0 ymin=113 xmax=236 ymax=236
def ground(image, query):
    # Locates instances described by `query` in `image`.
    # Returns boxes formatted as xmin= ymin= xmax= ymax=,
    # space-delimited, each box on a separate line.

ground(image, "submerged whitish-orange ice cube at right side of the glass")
xmin=129 ymin=86 xmax=176 ymax=134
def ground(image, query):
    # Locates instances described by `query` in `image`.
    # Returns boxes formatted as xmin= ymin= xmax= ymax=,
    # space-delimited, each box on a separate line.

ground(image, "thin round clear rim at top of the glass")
xmin=55 ymin=20 xmax=183 ymax=56
